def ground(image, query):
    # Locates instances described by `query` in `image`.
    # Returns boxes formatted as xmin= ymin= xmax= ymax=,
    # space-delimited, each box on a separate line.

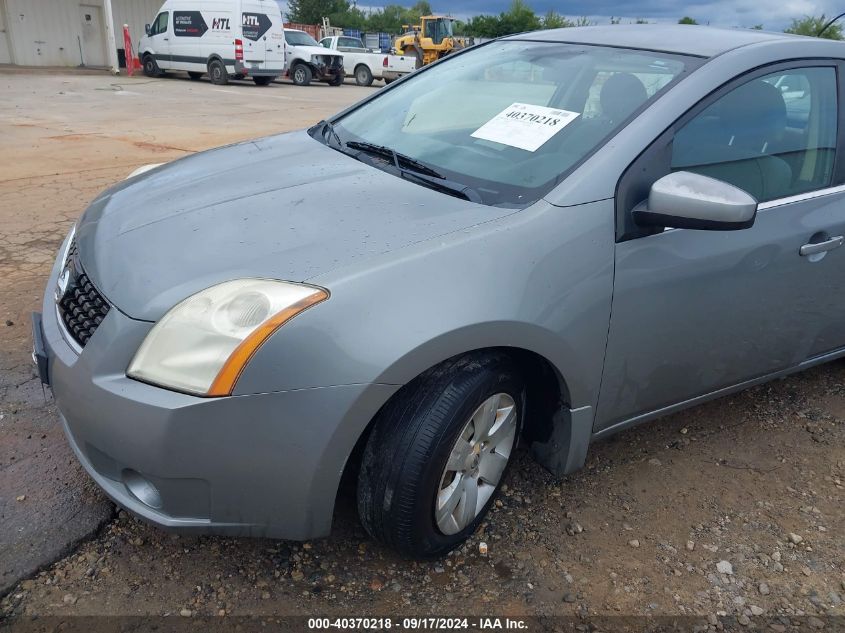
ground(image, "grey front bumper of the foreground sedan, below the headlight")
xmin=40 ymin=249 xmax=397 ymax=540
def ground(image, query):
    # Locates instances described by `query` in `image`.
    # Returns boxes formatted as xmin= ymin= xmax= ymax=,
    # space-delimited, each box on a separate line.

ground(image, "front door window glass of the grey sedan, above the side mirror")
xmin=671 ymin=67 xmax=837 ymax=202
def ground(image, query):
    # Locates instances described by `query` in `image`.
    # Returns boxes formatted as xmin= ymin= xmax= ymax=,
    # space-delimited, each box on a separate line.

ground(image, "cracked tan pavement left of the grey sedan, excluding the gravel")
xmin=0 ymin=71 xmax=377 ymax=594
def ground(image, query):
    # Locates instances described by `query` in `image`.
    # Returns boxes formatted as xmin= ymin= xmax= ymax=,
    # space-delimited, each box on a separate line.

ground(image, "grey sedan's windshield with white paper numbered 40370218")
xmin=324 ymin=40 xmax=697 ymax=207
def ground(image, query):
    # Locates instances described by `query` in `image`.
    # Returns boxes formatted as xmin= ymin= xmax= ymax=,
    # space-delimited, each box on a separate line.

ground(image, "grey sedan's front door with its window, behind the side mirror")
xmin=596 ymin=62 xmax=845 ymax=431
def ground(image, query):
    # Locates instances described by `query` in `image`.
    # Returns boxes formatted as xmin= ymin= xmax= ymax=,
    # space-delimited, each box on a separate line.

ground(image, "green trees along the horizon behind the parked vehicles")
xmin=287 ymin=0 xmax=843 ymax=40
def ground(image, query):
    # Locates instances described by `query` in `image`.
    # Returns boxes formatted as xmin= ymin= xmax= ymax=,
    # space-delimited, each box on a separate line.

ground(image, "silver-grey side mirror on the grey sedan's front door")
xmin=632 ymin=171 xmax=757 ymax=231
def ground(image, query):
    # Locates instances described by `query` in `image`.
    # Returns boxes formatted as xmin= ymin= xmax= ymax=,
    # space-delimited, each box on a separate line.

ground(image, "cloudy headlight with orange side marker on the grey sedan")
xmin=126 ymin=279 xmax=329 ymax=396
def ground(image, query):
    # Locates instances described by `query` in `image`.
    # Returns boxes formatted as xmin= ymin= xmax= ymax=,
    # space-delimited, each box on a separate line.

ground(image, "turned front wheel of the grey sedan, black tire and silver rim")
xmin=358 ymin=353 xmax=525 ymax=558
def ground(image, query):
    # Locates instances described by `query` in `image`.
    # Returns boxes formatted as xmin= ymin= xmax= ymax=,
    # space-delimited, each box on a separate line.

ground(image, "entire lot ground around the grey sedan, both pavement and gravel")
xmin=0 ymin=74 xmax=845 ymax=631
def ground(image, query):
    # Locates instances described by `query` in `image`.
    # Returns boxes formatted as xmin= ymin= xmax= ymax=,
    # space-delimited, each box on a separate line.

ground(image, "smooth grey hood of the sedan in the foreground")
xmin=77 ymin=132 xmax=513 ymax=321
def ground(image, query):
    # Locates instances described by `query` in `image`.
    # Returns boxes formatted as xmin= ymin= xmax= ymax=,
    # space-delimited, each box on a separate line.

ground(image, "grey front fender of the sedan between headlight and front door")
xmin=235 ymin=200 xmax=614 ymax=408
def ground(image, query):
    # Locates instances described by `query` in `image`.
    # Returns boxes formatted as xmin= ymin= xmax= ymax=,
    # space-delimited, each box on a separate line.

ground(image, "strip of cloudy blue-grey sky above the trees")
xmin=280 ymin=0 xmax=845 ymax=31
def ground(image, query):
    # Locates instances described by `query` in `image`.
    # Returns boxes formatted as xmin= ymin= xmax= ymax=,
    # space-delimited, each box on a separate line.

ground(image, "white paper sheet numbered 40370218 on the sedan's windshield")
xmin=472 ymin=103 xmax=580 ymax=152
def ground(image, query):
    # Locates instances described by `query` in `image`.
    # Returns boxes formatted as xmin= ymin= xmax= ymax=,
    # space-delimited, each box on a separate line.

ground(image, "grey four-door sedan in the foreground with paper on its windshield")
xmin=33 ymin=25 xmax=845 ymax=556
